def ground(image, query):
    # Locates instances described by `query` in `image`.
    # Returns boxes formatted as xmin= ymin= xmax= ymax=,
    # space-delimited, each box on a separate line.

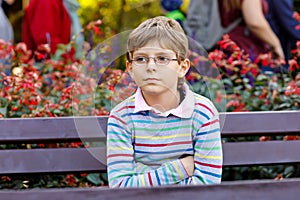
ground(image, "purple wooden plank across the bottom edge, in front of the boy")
xmin=0 ymin=179 xmax=300 ymax=200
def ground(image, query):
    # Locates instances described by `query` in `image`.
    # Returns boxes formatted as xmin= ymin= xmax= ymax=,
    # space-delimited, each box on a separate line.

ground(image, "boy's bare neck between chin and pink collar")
xmin=142 ymin=90 xmax=180 ymax=112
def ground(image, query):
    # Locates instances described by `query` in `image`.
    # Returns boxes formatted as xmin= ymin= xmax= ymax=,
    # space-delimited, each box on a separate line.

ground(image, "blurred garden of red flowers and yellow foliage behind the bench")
xmin=0 ymin=0 xmax=300 ymax=188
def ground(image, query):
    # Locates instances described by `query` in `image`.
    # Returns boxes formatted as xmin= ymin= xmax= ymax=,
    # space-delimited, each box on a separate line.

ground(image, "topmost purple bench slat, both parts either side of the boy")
xmin=0 ymin=111 xmax=300 ymax=143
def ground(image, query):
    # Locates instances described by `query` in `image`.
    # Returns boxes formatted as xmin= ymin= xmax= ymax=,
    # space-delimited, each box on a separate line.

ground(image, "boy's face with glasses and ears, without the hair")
xmin=126 ymin=42 xmax=190 ymax=95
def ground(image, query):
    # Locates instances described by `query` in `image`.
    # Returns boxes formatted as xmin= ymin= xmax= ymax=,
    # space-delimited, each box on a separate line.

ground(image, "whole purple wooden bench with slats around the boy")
xmin=0 ymin=111 xmax=300 ymax=200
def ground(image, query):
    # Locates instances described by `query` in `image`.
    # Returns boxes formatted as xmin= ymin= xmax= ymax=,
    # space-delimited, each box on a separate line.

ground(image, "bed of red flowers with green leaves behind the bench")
xmin=0 ymin=24 xmax=300 ymax=188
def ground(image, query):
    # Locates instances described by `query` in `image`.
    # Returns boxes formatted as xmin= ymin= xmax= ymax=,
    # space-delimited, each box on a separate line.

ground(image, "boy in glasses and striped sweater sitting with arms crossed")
xmin=107 ymin=16 xmax=222 ymax=187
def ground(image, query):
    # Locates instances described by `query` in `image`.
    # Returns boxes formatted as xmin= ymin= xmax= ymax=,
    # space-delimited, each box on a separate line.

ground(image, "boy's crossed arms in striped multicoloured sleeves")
xmin=107 ymin=112 xmax=222 ymax=187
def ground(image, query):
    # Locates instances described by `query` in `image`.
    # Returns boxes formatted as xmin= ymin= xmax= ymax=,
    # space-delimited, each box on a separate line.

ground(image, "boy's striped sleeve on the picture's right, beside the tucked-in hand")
xmin=179 ymin=109 xmax=223 ymax=185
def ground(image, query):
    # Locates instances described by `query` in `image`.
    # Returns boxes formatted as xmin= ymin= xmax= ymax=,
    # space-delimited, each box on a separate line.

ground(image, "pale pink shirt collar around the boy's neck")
xmin=134 ymin=84 xmax=195 ymax=118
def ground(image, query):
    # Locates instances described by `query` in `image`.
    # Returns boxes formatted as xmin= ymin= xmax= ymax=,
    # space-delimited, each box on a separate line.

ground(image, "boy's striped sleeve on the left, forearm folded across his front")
xmin=107 ymin=114 xmax=188 ymax=188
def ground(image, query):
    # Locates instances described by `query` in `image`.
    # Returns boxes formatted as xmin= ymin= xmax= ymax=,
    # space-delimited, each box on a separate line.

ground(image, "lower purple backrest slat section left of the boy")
xmin=0 ymin=147 xmax=106 ymax=174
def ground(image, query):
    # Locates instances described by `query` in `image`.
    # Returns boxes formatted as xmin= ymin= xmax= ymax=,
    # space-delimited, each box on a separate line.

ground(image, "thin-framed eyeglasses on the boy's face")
xmin=130 ymin=56 xmax=178 ymax=67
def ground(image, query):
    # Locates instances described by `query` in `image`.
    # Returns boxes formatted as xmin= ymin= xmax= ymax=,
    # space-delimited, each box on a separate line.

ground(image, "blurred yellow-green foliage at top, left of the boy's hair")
xmin=78 ymin=0 xmax=162 ymax=38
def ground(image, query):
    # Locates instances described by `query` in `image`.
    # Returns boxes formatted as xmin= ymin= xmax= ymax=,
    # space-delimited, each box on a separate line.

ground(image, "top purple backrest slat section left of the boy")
xmin=0 ymin=116 xmax=107 ymax=143
